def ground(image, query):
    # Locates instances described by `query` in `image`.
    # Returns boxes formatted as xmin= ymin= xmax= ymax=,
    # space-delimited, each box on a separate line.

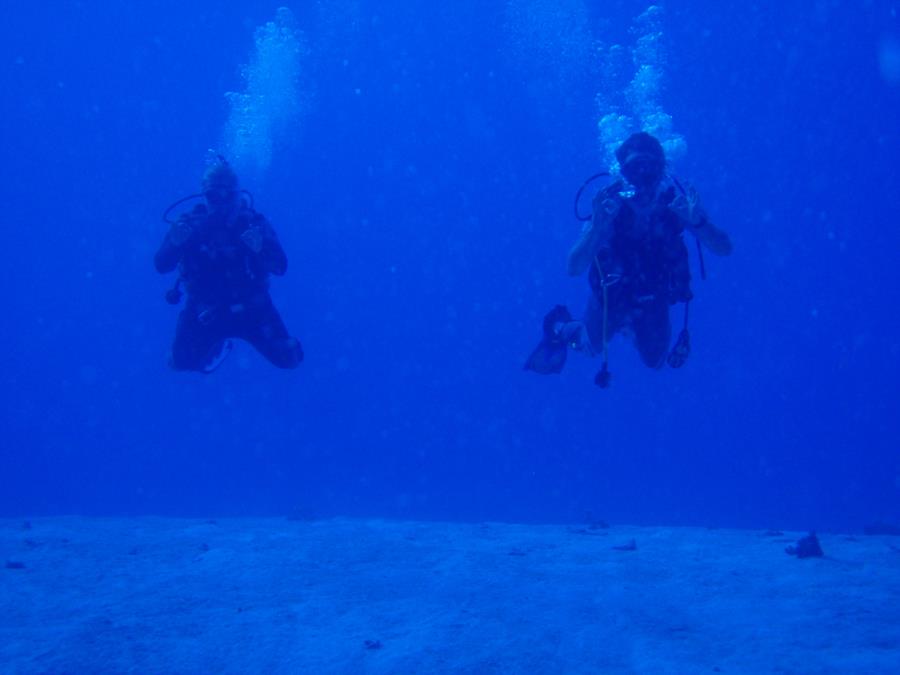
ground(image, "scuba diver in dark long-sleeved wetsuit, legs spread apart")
xmin=154 ymin=156 xmax=303 ymax=373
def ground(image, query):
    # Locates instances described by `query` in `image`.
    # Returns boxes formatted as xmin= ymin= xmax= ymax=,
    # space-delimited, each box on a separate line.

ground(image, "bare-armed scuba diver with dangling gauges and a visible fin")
xmin=525 ymin=132 xmax=732 ymax=387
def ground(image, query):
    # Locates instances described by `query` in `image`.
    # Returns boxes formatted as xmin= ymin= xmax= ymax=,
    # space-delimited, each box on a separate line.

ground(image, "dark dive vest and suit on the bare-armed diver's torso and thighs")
xmin=584 ymin=186 xmax=692 ymax=368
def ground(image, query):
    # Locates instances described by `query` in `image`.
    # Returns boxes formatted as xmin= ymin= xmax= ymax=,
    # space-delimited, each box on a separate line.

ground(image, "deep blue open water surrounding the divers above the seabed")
xmin=0 ymin=0 xmax=900 ymax=528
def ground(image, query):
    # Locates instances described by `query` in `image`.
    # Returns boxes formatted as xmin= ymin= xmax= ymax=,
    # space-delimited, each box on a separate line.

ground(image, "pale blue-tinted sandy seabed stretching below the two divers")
xmin=0 ymin=517 xmax=900 ymax=673
